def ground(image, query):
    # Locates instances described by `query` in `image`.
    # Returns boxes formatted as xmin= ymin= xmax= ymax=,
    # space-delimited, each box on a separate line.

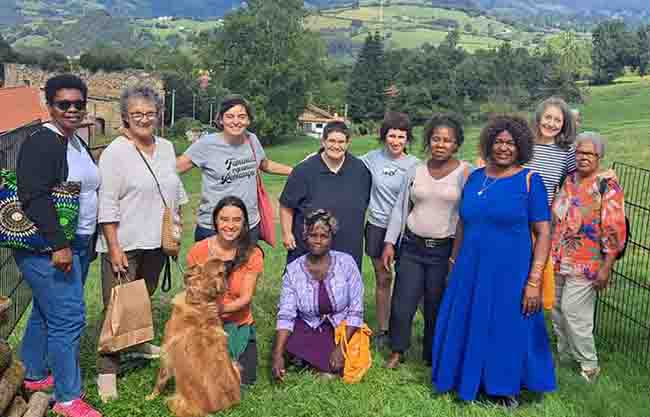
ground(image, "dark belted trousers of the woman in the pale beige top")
xmin=389 ymin=236 xmax=452 ymax=362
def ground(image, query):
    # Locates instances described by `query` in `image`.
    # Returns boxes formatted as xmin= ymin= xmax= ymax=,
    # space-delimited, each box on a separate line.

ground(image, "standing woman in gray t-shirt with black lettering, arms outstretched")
xmin=176 ymin=95 xmax=292 ymax=242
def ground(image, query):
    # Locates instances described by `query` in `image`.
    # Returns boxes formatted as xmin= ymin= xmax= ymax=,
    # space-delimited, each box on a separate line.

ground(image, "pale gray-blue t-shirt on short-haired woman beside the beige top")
xmin=361 ymin=148 xmax=419 ymax=228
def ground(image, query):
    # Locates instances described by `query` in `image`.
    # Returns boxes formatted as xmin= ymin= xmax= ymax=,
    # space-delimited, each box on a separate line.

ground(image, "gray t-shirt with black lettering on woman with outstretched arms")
xmin=185 ymin=133 xmax=266 ymax=229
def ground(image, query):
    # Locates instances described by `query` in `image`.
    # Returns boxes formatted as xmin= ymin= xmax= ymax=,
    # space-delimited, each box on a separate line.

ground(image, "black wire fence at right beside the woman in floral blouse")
xmin=595 ymin=162 xmax=650 ymax=368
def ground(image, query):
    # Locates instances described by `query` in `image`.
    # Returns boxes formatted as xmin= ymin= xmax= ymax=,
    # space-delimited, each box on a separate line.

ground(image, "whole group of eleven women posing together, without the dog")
xmin=14 ymin=75 xmax=625 ymax=417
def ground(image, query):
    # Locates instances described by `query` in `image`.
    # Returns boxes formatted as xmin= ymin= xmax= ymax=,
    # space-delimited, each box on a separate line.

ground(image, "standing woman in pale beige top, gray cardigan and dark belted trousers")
xmin=382 ymin=114 xmax=470 ymax=368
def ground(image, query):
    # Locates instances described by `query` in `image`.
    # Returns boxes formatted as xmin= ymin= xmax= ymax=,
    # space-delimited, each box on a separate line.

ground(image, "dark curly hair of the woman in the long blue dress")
xmin=479 ymin=114 xmax=535 ymax=165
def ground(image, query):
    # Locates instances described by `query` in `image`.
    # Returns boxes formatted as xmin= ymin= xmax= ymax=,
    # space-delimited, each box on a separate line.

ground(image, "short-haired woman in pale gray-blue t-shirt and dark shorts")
xmin=361 ymin=112 xmax=419 ymax=346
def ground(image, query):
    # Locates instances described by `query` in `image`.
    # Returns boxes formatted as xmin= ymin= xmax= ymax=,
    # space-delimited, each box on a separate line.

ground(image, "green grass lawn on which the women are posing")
xmin=12 ymin=78 xmax=650 ymax=417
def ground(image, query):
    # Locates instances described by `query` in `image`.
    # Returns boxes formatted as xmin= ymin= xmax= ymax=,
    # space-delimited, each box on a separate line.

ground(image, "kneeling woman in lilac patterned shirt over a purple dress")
xmin=272 ymin=209 xmax=363 ymax=381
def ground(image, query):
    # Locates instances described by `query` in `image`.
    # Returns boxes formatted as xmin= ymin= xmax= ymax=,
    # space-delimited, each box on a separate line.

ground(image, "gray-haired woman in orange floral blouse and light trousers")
xmin=551 ymin=132 xmax=626 ymax=382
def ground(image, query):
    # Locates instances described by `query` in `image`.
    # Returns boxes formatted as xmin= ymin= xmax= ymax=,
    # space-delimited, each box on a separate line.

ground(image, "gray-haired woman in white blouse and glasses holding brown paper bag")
xmin=97 ymin=85 xmax=188 ymax=401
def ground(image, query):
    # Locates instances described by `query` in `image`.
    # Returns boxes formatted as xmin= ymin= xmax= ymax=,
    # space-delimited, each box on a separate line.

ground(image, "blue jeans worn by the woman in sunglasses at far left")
xmin=14 ymin=235 xmax=91 ymax=402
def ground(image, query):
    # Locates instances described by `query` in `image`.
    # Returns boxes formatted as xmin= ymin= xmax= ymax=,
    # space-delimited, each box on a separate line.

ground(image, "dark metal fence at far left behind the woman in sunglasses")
xmin=0 ymin=123 xmax=39 ymax=339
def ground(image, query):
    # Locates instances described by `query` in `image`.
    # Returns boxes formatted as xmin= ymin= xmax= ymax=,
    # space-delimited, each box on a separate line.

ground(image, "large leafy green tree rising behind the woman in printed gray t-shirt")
xmin=192 ymin=0 xmax=325 ymax=142
